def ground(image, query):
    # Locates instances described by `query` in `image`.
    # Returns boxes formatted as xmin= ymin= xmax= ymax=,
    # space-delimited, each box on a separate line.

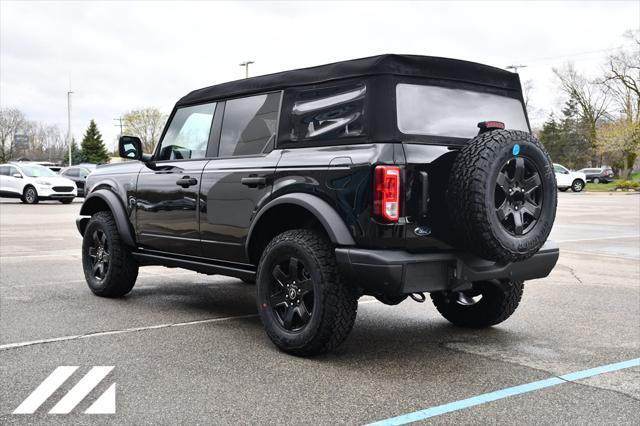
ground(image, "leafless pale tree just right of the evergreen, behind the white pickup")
xmin=553 ymin=64 xmax=611 ymax=165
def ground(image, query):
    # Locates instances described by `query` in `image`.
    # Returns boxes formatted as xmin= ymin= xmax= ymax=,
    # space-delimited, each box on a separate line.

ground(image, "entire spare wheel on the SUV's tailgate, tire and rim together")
xmin=447 ymin=130 xmax=557 ymax=262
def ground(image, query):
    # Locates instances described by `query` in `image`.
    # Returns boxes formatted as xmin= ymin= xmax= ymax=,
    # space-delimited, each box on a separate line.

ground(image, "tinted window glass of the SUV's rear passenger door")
xmin=218 ymin=93 xmax=280 ymax=157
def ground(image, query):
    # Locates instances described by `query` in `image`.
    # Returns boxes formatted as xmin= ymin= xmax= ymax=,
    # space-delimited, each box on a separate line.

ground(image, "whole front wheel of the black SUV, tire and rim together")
xmin=82 ymin=211 xmax=138 ymax=297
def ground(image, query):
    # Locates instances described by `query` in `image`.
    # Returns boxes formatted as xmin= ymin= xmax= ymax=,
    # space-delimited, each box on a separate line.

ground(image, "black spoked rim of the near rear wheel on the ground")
xmin=269 ymin=257 xmax=314 ymax=332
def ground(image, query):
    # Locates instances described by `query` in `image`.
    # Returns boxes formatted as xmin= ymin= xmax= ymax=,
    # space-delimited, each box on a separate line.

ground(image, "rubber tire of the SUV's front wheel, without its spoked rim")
xmin=82 ymin=211 xmax=138 ymax=297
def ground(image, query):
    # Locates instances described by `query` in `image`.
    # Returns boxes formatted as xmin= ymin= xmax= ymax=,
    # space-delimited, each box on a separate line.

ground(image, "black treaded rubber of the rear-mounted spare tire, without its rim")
xmin=447 ymin=130 xmax=558 ymax=262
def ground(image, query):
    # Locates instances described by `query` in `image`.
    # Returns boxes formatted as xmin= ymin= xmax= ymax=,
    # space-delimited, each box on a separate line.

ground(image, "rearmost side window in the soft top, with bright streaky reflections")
xmin=289 ymin=82 xmax=367 ymax=142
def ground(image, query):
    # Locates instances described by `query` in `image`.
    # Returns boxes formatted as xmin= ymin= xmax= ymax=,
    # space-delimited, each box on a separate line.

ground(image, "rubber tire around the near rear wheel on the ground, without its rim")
xmin=257 ymin=229 xmax=358 ymax=356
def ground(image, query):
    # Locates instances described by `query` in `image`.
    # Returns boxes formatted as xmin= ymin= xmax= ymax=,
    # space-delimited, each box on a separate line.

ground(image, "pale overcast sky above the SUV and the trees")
xmin=0 ymin=0 xmax=640 ymax=150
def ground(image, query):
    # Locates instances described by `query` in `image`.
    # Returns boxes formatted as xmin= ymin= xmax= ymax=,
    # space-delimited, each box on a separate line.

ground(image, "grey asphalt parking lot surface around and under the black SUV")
xmin=0 ymin=193 xmax=640 ymax=425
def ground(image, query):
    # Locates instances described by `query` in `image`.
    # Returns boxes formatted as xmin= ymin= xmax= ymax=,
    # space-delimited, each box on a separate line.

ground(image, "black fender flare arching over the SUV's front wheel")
xmin=76 ymin=189 xmax=136 ymax=247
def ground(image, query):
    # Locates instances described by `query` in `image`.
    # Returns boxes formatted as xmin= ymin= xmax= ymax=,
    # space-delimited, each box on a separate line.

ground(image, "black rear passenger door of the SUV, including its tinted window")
xmin=200 ymin=92 xmax=281 ymax=262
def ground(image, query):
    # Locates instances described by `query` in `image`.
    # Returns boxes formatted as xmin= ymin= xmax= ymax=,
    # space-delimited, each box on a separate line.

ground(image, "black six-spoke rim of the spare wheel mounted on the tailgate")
xmin=495 ymin=157 xmax=543 ymax=235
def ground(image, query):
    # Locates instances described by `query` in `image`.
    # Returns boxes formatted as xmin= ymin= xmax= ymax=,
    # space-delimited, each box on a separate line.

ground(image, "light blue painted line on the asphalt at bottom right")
xmin=369 ymin=358 xmax=640 ymax=426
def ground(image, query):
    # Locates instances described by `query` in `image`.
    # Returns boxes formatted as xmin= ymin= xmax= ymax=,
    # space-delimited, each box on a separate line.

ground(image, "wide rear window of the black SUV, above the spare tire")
xmin=396 ymin=84 xmax=529 ymax=138
